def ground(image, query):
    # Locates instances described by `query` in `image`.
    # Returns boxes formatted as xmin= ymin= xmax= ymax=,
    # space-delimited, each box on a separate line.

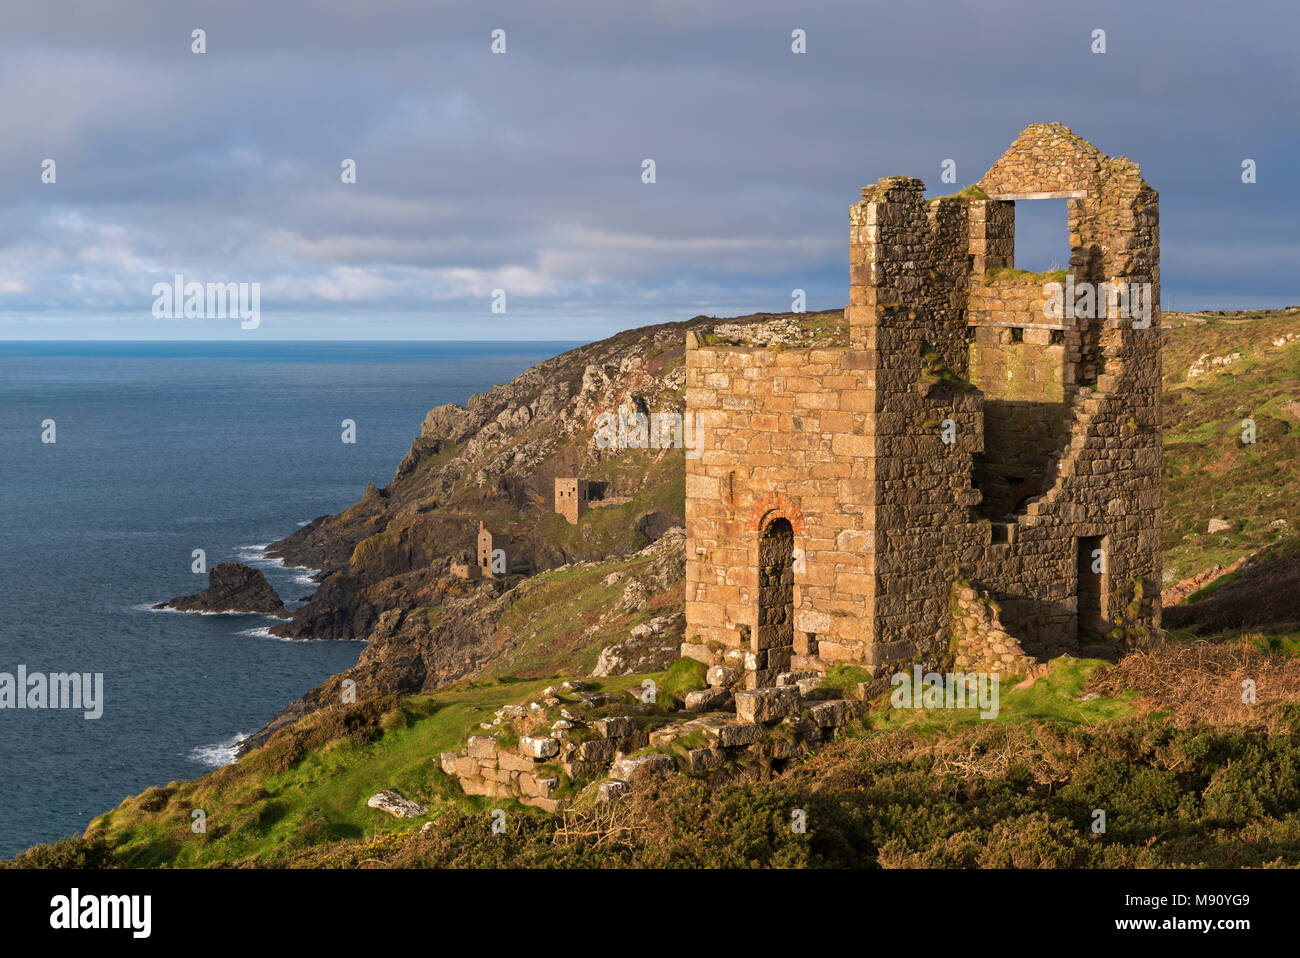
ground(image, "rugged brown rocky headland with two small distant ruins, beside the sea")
xmin=242 ymin=313 xmax=844 ymax=751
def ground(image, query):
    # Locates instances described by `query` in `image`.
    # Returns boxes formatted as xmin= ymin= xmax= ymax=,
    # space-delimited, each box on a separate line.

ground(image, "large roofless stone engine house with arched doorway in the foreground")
xmin=683 ymin=123 xmax=1162 ymax=688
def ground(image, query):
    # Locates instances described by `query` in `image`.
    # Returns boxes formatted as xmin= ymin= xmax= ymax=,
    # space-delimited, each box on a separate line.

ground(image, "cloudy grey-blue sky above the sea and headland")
xmin=0 ymin=0 xmax=1300 ymax=341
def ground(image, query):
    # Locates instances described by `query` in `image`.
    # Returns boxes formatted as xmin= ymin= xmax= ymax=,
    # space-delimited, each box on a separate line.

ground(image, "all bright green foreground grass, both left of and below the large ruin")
xmin=71 ymin=662 xmax=1132 ymax=867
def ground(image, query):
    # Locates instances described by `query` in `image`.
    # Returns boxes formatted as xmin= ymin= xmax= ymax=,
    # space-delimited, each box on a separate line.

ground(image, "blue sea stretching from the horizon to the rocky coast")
xmin=0 ymin=342 xmax=568 ymax=858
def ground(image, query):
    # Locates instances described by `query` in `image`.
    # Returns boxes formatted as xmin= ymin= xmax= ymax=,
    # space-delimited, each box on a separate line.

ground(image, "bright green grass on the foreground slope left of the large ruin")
xmin=87 ymin=663 xmax=686 ymax=867
